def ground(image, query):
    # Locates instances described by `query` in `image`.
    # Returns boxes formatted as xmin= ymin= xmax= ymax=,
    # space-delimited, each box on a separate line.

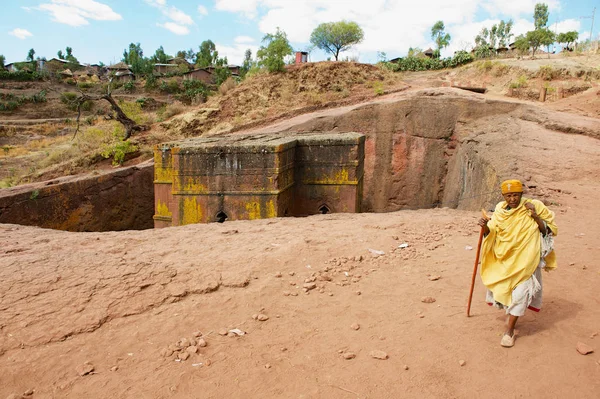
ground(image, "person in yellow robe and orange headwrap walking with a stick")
xmin=478 ymin=180 xmax=558 ymax=347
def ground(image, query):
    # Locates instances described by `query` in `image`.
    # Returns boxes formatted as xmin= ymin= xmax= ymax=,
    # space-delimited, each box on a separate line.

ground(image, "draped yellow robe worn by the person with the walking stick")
xmin=481 ymin=198 xmax=558 ymax=306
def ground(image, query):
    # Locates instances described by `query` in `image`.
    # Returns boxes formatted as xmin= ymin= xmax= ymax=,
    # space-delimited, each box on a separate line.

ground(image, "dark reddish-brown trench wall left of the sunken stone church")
xmin=0 ymin=162 xmax=154 ymax=231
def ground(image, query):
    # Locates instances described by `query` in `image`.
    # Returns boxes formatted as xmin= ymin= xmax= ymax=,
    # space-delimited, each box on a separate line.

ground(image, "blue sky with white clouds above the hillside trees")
xmin=0 ymin=0 xmax=600 ymax=64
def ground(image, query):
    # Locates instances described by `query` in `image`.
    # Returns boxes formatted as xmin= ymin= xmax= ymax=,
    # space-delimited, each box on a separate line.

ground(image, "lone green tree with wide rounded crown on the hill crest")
xmin=310 ymin=21 xmax=365 ymax=61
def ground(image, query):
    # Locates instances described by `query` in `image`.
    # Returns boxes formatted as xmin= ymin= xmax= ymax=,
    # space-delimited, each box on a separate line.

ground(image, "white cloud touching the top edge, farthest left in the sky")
xmin=36 ymin=0 xmax=123 ymax=26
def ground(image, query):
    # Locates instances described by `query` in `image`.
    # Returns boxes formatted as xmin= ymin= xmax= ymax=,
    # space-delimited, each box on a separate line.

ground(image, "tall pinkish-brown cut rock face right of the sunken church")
xmin=276 ymin=91 xmax=520 ymax=212
